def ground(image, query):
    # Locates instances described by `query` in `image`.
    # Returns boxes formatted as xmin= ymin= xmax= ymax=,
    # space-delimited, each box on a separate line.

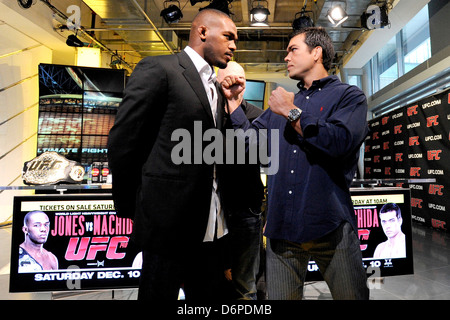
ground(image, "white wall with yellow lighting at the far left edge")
xmin=0 ymin=0 xmax=71 ymax=224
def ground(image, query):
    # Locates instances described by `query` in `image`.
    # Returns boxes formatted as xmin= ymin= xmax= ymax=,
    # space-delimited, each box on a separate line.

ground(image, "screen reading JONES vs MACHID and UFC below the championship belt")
xmin=10 ymin=194 xmax=142 ymax=292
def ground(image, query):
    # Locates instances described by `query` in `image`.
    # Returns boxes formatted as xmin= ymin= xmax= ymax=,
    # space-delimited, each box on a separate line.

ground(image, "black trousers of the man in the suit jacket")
xmin=138 ymin=240 xmax=224 ymax=301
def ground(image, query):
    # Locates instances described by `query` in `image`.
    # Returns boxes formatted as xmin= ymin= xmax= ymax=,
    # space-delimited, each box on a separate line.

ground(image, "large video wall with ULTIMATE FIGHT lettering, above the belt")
xmin=37 ymin=64 xmax=126 ymax=167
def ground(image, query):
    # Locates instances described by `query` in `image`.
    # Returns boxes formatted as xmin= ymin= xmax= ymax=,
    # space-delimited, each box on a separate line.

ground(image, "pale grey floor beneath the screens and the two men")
xmin=0 ymin=224 xmax=450 ymax=300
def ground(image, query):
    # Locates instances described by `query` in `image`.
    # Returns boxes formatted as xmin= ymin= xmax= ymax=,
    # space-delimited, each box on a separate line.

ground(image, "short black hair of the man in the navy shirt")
xmin=289 ymin=27 xmax=334 ymax=71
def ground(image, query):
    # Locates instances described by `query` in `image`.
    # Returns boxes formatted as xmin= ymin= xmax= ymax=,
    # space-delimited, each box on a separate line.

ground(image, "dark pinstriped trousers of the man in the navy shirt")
xmin=266 ymin=223 xmax=369 ymax=300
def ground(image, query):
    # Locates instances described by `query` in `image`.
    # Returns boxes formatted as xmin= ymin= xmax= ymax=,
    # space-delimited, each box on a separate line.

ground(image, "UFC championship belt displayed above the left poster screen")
xmin=22 ymin=151 xmax=84 ymax=185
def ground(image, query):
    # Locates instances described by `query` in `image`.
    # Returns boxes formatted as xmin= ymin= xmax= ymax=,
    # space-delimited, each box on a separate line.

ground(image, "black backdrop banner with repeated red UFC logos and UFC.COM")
xmin=364 ymin=90 xmax=450 ymax=232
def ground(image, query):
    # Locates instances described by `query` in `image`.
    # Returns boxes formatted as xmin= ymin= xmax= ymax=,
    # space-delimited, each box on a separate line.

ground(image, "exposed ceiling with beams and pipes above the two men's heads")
xmin=84 ymin=0 xmax=371 ymax=68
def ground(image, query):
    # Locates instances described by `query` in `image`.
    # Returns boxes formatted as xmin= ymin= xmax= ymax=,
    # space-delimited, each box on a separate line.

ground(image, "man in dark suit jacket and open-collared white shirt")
xmin=108 ymin=9 xmax=237 ymax=300
